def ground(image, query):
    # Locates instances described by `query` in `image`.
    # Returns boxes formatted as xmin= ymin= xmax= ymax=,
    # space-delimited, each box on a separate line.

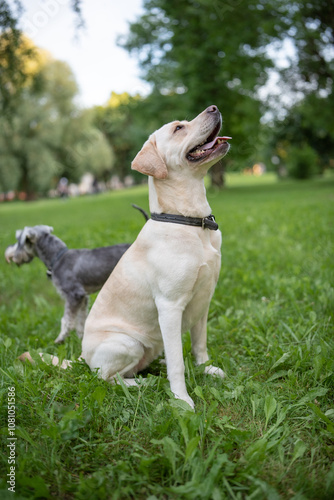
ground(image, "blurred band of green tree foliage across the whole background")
xmin=0 ymin=0 xmax=334 ymax=196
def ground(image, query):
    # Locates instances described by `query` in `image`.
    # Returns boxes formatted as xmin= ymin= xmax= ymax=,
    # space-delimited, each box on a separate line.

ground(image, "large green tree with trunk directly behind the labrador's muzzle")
xmin=120 ymin=0 xmax=290 ymax=186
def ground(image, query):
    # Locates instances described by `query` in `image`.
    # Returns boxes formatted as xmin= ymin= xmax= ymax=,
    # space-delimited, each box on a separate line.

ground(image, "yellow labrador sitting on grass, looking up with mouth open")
xmin=23 ymin=106 xmax=230 ymax=408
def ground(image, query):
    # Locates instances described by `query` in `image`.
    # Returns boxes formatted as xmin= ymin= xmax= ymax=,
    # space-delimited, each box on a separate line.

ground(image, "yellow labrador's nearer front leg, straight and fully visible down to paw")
xmin=156 ymin=299 xmax=195 ymax=408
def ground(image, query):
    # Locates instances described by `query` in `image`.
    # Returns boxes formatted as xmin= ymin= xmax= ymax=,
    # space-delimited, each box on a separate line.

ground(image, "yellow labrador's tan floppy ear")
xmin=131 ymin=136 xmax=168 ymax=179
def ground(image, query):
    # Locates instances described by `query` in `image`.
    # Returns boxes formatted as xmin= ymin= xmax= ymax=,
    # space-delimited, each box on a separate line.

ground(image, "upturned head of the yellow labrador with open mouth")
xmin=132 ymin=106 xmax=231 ymax=179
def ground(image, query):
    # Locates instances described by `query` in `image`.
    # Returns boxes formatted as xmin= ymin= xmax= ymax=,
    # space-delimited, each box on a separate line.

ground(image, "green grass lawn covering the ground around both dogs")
xmin=0 ymin=176 xmax=334 ymax=500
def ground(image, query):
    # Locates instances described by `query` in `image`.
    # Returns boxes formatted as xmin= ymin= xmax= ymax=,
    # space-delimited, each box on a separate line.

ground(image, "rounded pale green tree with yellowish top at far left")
xmin=0 ymin=50 xmax=113 ymax=198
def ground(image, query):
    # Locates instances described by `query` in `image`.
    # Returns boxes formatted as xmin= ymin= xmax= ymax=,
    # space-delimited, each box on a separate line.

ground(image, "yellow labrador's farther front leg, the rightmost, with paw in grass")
xmin=190 ymin=311 xmax=225 ymax=378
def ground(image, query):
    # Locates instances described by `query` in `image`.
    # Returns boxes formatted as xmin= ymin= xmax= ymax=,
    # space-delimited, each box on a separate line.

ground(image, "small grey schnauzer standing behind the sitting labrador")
xmin=5 ymin=227 xmax=132 ymax=343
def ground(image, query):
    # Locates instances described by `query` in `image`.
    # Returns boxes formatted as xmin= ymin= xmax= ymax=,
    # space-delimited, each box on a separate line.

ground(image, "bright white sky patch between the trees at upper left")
xmin=20 ymin=0 xmax=149 ymax=107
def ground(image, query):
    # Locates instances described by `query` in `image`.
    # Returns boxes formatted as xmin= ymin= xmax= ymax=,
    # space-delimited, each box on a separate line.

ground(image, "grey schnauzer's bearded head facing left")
xmin=5 ymin=225 xmax=53 ymax=266
